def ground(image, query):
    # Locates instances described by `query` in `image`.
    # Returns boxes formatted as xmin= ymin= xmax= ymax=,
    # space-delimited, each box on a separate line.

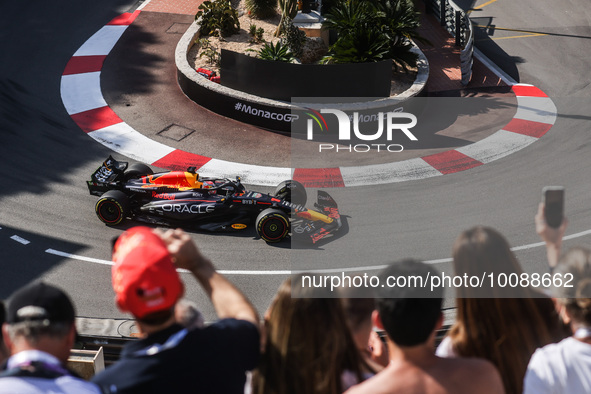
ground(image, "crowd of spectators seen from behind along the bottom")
xmin=0 ymin=204 xmax=591 ymax=394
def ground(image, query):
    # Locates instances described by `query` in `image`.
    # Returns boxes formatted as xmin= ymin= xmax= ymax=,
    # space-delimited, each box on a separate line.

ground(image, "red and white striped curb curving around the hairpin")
xmin=61 ymin=10 xmax=556 ymax=188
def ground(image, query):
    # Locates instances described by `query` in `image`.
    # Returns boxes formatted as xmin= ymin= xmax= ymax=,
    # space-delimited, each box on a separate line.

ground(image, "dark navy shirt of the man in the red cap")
xmin=92 ymin=319 xmax=260 ymax=394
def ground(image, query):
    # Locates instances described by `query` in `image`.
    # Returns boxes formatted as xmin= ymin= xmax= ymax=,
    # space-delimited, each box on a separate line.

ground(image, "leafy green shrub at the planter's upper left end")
xmin=195 ymin=0 xmax=240 ymax=37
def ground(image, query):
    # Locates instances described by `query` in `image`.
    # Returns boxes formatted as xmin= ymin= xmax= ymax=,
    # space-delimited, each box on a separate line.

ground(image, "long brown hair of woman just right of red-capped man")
xmin=253 ymin=275 xmax=363 ymax=394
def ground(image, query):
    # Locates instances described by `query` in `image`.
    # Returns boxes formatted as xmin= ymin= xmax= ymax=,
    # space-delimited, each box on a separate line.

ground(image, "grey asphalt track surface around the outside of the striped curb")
xmin=0 ymin=0 xmax=591 ymax=319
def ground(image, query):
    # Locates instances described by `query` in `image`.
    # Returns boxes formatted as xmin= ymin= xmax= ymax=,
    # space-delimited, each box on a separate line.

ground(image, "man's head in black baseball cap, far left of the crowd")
xmin=3 ymin=282 xmax=76 ymax=362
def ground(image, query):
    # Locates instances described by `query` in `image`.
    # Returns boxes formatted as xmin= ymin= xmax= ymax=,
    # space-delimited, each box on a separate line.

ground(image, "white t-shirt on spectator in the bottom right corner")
xmin=523 ymin=337 xmax=591 ymax=394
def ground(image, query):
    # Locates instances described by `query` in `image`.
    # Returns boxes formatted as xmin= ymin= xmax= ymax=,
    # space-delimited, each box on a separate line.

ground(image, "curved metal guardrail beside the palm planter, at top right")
xmin=425 ymin=0 xmax=474 ymax=86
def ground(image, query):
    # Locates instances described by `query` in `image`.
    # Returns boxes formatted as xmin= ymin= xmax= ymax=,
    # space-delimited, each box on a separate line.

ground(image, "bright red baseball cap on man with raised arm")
xmin=112 ymin=226 xmax=184 ymax=319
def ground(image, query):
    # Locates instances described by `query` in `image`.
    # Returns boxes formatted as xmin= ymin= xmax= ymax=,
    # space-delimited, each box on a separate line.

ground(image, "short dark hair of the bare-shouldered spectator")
xmin=376 ymin=259 xmax=443 ymax=346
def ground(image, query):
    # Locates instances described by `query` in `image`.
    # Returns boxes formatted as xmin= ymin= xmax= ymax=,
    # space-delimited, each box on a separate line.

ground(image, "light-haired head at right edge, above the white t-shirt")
xmin=553 ymin=248 xmax=591 ymax=327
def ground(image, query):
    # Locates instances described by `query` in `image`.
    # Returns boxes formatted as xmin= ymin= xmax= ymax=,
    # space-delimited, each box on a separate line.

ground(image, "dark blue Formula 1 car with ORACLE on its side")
xmin=87 ymin=156 xmax=341 ymax=243
